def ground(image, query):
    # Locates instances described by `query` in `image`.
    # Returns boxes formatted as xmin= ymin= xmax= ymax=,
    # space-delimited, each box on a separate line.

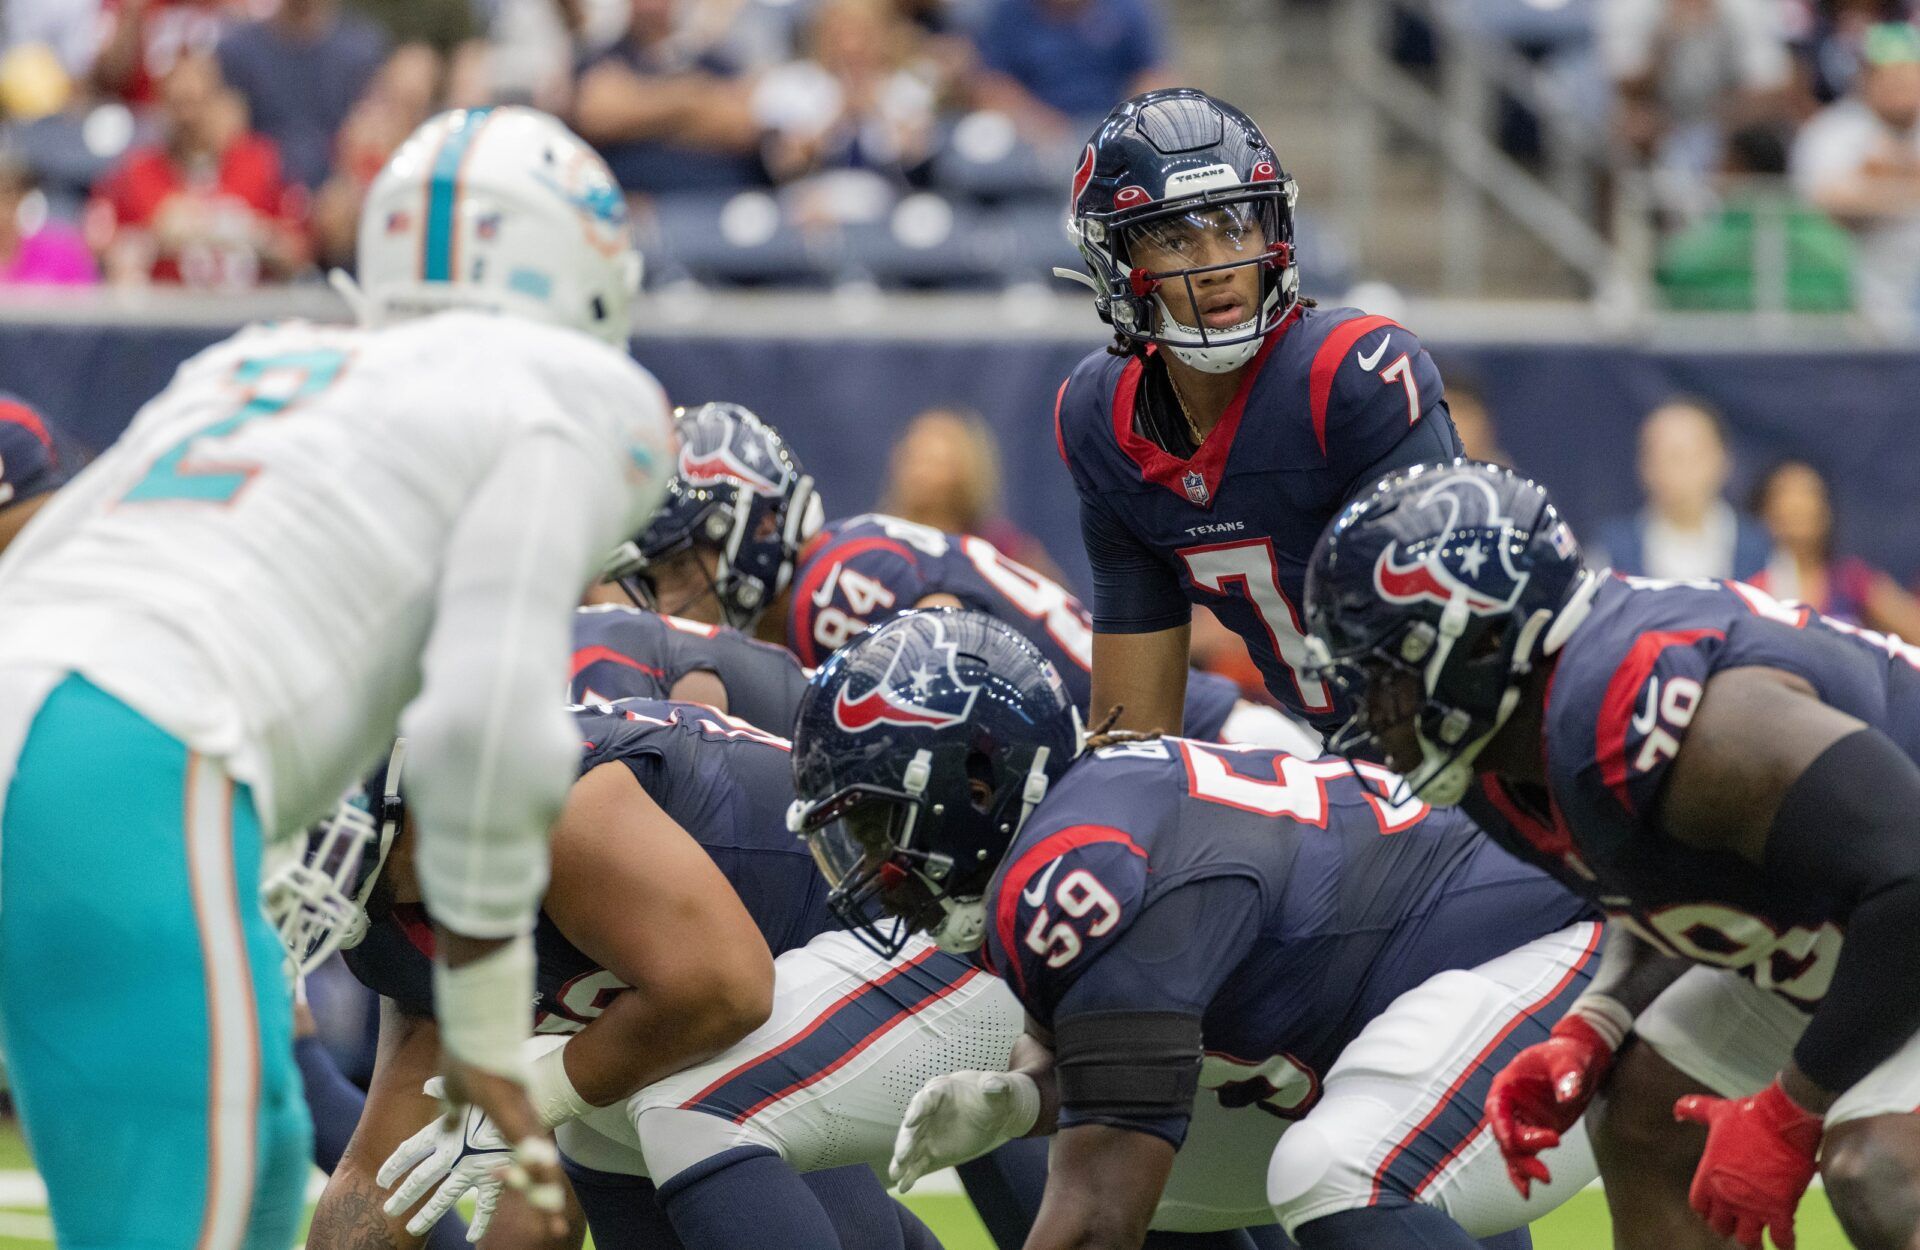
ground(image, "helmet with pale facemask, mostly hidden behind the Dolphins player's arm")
xmin=261 ymin=739 xmax=407 ymax=979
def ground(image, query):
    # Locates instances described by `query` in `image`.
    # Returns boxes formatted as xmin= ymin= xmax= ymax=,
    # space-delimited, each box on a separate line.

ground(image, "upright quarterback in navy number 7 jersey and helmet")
xmin=1054 ymin=88 xmax=1459 ymax=745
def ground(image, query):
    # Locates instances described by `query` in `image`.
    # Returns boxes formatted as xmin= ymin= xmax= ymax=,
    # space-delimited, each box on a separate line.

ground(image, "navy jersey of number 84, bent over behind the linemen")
xmin=787 ymin=513 xmax=1240 ymax=739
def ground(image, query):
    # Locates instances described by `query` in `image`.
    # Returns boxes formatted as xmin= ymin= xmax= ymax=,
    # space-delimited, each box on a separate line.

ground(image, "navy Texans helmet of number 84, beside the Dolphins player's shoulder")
xmin=607 ymin=403 xmax=826 ymax=630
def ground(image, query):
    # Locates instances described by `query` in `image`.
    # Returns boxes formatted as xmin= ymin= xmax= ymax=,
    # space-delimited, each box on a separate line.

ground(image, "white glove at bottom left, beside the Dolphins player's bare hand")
xmin=374 ymin=1077 xmax=563 ymax=1242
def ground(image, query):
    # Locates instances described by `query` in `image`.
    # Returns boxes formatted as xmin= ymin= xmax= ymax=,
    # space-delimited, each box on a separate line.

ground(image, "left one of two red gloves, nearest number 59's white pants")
xmin=1486 ymin=1016 xmax=1613 ymax=1198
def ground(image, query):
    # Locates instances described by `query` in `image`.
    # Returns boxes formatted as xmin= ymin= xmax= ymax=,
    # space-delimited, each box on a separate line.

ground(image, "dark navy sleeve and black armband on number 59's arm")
xmin=1054 ymin=877 xmax=1261 ymax=1148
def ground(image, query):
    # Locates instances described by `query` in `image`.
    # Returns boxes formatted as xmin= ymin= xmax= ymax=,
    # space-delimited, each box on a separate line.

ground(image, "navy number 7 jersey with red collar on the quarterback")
xmin=1054 ymin=309 xmax=1459 ymax=730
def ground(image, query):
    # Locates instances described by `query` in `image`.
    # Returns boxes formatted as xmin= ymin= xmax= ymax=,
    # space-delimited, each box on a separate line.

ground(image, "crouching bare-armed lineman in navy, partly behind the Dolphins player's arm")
xmin=309 ymin=699 xmax=1018 ymax=1250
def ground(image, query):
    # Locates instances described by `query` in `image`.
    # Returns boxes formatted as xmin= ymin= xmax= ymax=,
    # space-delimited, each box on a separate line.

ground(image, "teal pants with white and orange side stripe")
xmin=0 ymin=676 xmax=311 ymax=1250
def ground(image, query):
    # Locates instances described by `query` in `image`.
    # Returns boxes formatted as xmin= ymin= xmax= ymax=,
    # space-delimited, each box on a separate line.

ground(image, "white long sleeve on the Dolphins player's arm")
xmin=401 ymin=428 xmax=626 ymax=937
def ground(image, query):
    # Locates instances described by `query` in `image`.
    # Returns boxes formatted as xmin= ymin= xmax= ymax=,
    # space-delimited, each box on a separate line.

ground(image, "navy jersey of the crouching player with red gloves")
xmin=1463 ymin=576 xmax=1920 ymax=1006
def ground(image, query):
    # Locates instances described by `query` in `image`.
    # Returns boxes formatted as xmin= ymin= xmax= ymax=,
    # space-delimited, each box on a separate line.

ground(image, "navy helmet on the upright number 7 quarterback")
xmin=1054 ymin=86 xmax=1300 ymax=373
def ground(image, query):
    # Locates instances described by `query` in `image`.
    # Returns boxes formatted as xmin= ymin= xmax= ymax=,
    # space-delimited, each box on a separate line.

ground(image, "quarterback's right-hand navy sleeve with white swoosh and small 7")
xmin=1308 ymin=315 xmax=1459 ymax=507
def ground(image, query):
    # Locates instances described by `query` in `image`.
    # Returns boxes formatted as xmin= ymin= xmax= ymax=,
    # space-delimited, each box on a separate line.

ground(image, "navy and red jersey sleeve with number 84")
xmin=787 ymin=534 xmax=929 ymax=668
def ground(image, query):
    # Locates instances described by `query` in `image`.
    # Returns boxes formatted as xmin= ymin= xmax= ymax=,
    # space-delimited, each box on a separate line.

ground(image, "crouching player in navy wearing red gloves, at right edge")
xmin=1309 ymin=463 xmax=1920 ymax=1250
